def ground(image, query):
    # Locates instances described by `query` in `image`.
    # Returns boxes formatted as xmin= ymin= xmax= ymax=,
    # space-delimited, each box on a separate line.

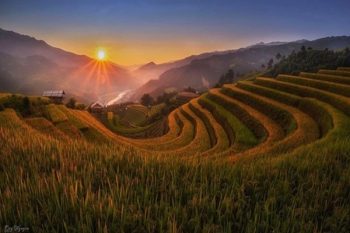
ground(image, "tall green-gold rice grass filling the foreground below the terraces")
xmin=0 ymin=110 xmax=350 ymax=232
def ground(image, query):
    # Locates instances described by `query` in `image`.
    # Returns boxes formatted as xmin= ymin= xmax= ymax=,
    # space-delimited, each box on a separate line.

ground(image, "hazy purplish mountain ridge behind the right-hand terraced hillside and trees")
xmin=132 ymin=36 xmax=350 ymax=100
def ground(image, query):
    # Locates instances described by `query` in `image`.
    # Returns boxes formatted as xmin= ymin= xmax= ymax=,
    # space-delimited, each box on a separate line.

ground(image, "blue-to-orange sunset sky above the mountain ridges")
xmin=0 ymin=0 xmax=350 ymax=65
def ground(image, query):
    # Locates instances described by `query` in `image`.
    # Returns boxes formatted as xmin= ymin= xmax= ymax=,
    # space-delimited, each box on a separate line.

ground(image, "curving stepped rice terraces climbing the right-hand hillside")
xmin=126 ymin=65 xmax=350 ymax=159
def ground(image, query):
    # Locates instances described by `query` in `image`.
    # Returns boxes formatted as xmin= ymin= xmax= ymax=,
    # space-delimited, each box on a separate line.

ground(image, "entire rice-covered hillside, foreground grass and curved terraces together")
xmin=0 ymin=68 xmax=350 ymax=232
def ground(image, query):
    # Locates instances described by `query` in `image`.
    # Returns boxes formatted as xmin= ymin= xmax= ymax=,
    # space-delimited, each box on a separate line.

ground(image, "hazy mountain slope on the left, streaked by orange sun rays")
xmin=0 ymin=29 xmax=140 ymax=101
